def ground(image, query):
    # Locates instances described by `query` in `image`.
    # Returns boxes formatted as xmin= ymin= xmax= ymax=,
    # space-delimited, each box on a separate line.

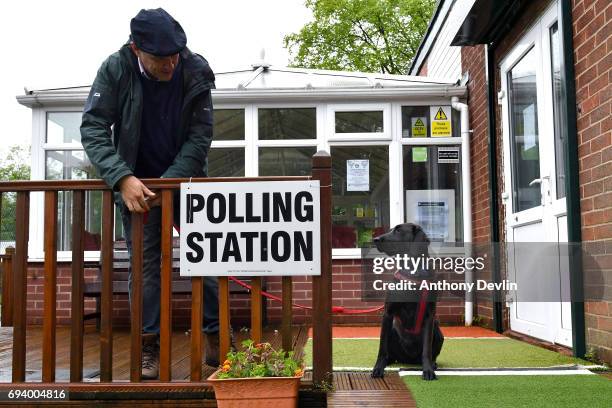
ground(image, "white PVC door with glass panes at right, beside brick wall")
xmin=500 ymin=4 xmax=571 ymax=346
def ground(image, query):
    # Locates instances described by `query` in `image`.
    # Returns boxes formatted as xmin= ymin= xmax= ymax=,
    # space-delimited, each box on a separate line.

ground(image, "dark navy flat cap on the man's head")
xmin=130 ymin=8 xmax=187 ymax=57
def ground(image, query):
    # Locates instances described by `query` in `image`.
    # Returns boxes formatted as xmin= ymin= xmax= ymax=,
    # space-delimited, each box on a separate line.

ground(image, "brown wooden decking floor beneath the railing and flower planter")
xmin=0 ymin=326 xmax=416 ymax=408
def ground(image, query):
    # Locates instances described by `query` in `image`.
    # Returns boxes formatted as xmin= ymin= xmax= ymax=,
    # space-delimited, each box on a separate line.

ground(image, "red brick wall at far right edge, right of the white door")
xmin=572 ymin=0 xmax=612 ymax=362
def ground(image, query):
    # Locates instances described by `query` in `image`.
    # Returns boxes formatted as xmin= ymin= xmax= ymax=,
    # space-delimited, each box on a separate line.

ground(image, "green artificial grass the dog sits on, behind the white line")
xmin=304 ymin=338 xmax=591 ymax=368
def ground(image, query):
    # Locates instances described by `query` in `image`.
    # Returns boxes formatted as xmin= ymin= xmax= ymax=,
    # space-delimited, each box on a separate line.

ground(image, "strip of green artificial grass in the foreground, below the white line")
xmin=402 ymin=375 xmax=612 ymax=408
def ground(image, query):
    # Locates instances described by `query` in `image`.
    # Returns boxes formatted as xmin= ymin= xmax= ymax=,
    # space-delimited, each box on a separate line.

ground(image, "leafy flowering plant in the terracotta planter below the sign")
xmin=217 ymin=340 xmax=304 ymax=379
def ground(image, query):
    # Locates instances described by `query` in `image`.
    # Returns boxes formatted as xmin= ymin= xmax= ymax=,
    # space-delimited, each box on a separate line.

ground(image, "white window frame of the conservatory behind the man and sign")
xmin=29 ymin=98 xmax=466 ymax=261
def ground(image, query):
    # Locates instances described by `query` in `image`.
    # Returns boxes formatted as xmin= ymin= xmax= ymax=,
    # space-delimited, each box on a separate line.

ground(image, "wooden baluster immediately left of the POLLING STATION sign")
xmin=159 ymin=190 xmax=173 ymax=381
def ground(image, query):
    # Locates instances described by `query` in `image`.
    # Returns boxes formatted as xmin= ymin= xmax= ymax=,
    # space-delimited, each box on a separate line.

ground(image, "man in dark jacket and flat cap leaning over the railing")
xmin=81 ymin=8 xmax=219 ymax=379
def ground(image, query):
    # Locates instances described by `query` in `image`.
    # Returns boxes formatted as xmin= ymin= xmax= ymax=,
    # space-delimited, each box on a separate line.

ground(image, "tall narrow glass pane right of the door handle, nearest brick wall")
xmin=550 ymin=23 xmax=567 ymax=199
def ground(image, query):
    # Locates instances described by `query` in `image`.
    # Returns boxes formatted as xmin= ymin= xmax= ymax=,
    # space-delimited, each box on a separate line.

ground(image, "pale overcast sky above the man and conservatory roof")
xmin=0 ymin=0 xmax=312 ymax=153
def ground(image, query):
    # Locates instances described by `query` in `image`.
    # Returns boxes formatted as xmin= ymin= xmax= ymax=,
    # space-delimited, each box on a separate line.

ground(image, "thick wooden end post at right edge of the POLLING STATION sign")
xmin=312 ymin=151 xmax=332 ymax=384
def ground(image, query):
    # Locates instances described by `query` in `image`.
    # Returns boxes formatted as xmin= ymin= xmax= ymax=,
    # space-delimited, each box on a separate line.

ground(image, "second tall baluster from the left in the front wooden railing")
xmin=42 ymin=191 xmax=57 ymax=382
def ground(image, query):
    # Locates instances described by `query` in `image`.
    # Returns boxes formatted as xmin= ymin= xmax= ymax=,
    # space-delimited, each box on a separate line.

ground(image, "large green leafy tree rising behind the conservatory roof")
xmin=284 ymin=0 xmax=435 ymax=75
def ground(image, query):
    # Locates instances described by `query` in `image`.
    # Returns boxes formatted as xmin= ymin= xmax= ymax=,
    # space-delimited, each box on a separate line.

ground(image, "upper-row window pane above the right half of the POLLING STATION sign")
xmin=257 ymin=108 xmax=317 ymax=140
